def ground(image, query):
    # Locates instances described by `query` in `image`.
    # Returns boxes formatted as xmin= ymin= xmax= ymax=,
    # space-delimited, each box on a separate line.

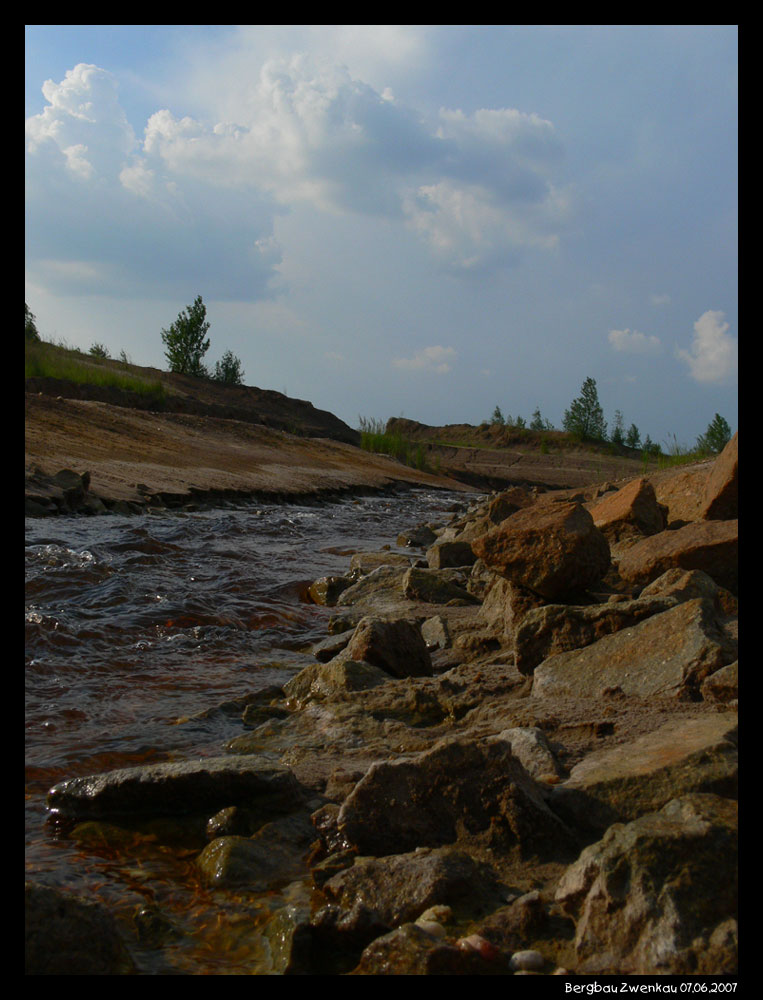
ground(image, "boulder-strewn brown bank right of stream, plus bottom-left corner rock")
xmin=27 ymin=436 xmax=738 ymax=977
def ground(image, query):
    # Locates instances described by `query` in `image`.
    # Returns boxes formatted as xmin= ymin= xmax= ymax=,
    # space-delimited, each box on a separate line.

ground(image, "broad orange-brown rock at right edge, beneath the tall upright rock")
xmin=618 ymin=521 xmax=739 ymax=594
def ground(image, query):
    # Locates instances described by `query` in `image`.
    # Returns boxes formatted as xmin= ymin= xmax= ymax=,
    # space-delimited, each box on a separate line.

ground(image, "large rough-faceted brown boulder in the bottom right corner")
xmin=556 ymin=794 xmax=738 ymax=975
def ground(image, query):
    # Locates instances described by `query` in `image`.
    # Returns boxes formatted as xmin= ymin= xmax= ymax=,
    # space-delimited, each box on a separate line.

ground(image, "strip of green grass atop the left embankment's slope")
xmin=24 ymin=340 xmax=167 ymax=402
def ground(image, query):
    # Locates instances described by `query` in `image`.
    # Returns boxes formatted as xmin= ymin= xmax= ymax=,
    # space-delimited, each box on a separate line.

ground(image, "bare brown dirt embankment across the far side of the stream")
xmin=25 ymin=362 xmax=676 ymax=513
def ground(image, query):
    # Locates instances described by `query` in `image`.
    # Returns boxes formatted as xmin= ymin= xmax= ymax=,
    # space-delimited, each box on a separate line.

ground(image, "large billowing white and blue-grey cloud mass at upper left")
xmin=27 ymin=51 xmax=570 ymax=301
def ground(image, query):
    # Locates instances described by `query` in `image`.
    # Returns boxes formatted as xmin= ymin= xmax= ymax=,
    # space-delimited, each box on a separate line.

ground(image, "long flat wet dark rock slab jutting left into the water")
xmin=47 ymin=755 xmax=302 ymax=819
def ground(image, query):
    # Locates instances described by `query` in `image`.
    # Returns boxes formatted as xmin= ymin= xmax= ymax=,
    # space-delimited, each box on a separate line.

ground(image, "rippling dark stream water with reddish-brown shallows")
xmin=25 ymin=491 xmax=463 ymax=975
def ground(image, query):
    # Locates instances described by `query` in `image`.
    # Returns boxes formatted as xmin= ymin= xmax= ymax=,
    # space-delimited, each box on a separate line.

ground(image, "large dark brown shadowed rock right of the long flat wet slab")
xmin=337 ymin=738 xmax=570 ymax=856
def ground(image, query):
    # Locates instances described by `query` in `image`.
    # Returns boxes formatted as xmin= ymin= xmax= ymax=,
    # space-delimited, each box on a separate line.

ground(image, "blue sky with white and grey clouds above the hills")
xmin=25 ymin=25 xmax=739 ymax=447
